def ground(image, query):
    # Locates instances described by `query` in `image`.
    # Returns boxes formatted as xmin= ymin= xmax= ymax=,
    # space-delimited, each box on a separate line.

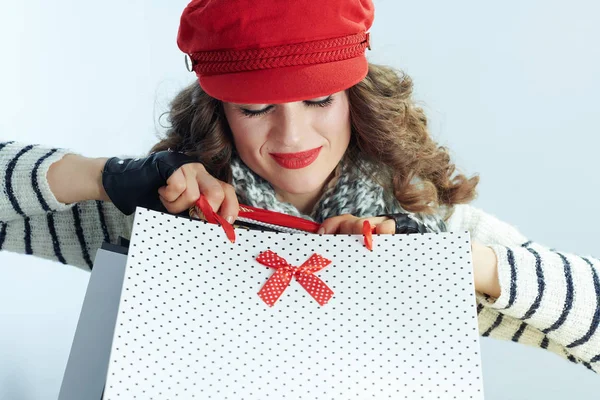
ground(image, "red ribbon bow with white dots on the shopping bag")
xmin=256 ymin=250 xmax=333 ymax=307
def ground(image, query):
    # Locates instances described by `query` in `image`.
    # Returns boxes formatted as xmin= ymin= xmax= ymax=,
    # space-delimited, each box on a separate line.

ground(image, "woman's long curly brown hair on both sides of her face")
xmin=151 ymin=64 xmax=479 ymax=218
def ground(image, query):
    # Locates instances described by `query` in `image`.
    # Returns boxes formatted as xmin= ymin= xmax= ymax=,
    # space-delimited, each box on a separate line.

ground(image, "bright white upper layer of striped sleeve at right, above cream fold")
xmin=449 ymin=205 xmax=600 ymax=370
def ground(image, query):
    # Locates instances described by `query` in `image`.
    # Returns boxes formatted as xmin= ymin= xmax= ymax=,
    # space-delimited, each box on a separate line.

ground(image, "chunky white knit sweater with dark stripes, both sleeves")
xmin=0 ymin=142 xmax=600 ymax=373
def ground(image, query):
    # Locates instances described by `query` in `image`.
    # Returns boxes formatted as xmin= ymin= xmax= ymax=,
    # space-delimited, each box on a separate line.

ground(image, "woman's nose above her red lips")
xmin=271 ymin=102 xmax=310 ymax=151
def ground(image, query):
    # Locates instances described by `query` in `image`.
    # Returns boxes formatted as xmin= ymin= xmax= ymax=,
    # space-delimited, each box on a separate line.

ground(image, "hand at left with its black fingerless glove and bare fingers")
xmin=102 ymin=150 xmax=239 ymax=220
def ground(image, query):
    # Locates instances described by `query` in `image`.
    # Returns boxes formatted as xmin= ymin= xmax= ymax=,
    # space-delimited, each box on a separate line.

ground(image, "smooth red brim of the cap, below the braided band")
xmin=198 ymin=55 xmax=369 ymax=104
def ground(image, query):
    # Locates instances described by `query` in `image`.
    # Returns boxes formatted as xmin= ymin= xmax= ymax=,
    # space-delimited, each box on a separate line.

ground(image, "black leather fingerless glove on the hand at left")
xmin=102 ymin=150 xmax=198 ymax=215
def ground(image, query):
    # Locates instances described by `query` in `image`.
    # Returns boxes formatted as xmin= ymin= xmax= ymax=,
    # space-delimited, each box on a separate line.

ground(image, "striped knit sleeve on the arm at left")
xmin=0 ymin=142 xmax=133 ymax=269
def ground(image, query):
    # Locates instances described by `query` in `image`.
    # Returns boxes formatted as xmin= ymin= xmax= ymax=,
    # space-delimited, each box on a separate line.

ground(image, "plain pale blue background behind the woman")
xmin=0 ymin=0 xmax=600 ymax=400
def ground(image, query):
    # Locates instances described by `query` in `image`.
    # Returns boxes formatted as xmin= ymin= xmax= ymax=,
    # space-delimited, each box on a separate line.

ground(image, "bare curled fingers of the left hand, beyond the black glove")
xmin=158 ymin=163 xmax=239 ymax=224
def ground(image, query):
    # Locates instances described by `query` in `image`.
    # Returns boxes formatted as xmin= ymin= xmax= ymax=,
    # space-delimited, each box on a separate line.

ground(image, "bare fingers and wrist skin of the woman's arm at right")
xmin=317 ymin=214 xmax=500 ymax=298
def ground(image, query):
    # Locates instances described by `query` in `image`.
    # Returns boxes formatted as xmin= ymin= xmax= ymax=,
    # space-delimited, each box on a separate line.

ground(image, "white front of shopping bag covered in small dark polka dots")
xmin=103 ymin=208 xmax=483 ymax=400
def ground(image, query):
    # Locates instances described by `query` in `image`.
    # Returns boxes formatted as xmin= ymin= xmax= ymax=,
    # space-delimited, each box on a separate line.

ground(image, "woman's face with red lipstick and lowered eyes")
xmin=223 ymin=91 xmax=350 ymax=197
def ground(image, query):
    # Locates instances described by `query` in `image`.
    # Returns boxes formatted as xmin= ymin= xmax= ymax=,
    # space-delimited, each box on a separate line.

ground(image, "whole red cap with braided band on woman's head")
xmin=177 ymin=0 xmax=374 ymax=104
